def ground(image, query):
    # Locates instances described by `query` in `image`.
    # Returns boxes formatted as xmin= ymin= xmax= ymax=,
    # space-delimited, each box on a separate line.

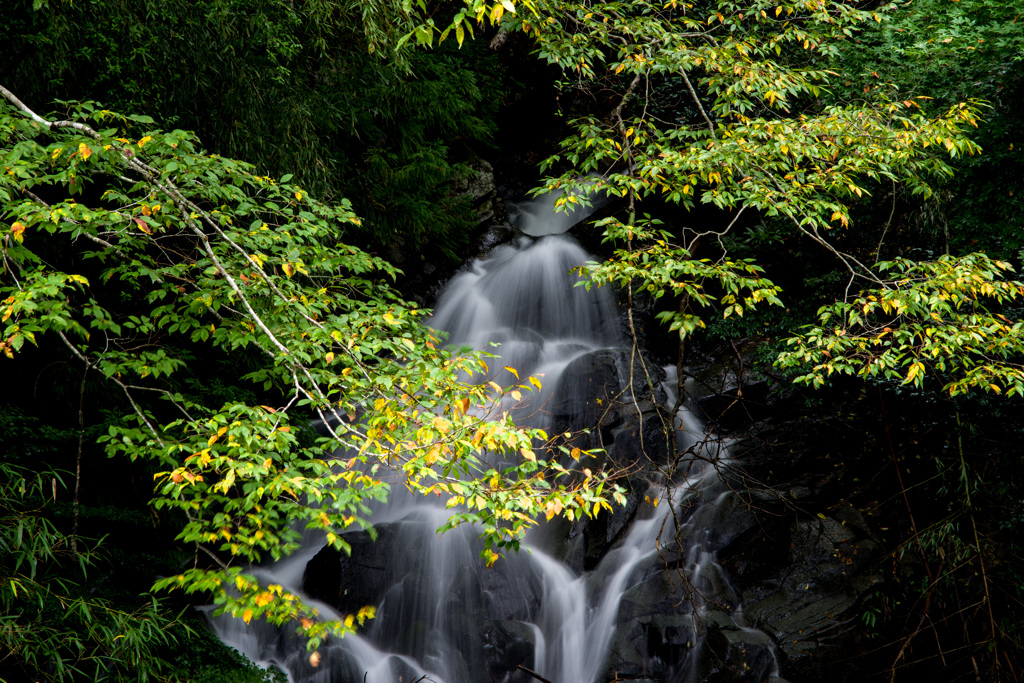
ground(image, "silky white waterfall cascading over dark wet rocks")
xmin=213 ymin=192 xmax=774 ymax=683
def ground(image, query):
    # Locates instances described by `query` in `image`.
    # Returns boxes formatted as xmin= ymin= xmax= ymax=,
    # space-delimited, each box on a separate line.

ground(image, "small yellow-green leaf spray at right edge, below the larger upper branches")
xmin=776 ymin=254 xmax=1024 ymax=396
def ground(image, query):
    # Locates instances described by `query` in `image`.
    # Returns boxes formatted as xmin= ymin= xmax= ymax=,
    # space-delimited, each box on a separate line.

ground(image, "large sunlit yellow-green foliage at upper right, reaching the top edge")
xmin=393 ymin=0 xmax=980 ymax=342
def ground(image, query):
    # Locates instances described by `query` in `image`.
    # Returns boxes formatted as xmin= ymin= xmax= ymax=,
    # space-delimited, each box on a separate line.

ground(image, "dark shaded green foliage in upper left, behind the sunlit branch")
xmin=0 ymin=0 xmax=503 ymax=258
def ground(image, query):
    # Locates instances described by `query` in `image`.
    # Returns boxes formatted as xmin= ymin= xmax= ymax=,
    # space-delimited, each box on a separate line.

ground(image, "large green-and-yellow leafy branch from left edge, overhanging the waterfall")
xmin=0 ymin=90 xmax=623 ymax=663
